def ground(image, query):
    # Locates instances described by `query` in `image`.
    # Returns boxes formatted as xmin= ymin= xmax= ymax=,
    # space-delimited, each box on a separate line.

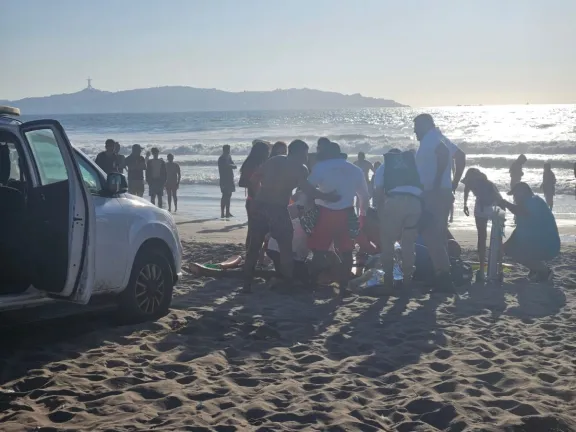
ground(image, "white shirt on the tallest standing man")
xmin=416 ymin=129 xmax=459 ymax=191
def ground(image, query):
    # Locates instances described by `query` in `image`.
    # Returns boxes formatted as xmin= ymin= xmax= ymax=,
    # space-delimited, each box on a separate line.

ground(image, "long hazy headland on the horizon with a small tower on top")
xmin=0 ymin=79 xmax=407 ymax=114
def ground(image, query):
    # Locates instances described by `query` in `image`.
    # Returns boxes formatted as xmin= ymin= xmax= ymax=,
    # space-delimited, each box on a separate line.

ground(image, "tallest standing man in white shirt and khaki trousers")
xmin=414 ymin=114 xmax=460 ymax=291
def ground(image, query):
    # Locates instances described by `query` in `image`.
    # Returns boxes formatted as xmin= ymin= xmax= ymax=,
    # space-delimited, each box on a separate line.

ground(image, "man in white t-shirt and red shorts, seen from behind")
xmin=308 ymin=143 xmax=370 ymax=293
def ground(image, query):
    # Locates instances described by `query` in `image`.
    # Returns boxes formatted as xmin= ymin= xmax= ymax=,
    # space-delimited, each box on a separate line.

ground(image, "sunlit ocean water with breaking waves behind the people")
xmin=24 ymin=105 xmax=576 ymax=217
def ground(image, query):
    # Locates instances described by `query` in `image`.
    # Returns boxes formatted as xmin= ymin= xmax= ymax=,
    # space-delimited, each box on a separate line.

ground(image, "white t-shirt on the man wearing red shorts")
xmin=308 ymin=159 xmax=370 ymax=212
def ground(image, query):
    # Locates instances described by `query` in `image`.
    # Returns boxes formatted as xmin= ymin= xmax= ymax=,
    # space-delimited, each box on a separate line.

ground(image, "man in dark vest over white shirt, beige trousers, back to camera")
xmin=374 ymin=149 xmax=422 ymax=288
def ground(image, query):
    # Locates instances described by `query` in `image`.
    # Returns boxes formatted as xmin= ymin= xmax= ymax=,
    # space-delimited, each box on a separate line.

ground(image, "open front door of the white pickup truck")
xmin=20 ymin=120 xmax=96 ymax=304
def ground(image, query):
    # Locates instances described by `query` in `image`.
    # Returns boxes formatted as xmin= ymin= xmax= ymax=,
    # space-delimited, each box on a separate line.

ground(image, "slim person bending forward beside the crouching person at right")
xmin=462 ymin=168 xmax=502 ymax=283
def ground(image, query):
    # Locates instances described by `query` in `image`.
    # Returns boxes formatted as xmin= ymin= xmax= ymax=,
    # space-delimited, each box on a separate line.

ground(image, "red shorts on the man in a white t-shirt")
xmin=308 ymin=206 xmax=356 ymax=252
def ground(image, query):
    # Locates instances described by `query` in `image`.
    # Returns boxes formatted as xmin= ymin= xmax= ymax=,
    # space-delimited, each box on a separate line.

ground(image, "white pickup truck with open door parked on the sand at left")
xmin=0 ymin=107 xmax=182 ymax=319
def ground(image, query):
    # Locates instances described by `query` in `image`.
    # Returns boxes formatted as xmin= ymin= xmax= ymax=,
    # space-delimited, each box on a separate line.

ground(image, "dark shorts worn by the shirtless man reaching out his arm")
xmin=248 ymin=200 xmax=294 ymax=245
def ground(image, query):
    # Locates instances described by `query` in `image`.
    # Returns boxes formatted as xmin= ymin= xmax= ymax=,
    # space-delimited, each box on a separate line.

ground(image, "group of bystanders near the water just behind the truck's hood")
xmin=96 ymin=139 xmax=182 ymax=211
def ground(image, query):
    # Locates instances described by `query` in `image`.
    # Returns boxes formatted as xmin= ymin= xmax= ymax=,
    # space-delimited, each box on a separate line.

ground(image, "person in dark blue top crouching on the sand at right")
xmin=498 ymin=182 xmax=560 ymax=282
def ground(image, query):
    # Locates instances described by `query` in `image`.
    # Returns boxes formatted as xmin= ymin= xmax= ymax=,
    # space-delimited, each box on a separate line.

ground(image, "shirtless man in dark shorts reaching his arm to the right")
xmin=244 ymin=140 xmax=340 ymax=292
